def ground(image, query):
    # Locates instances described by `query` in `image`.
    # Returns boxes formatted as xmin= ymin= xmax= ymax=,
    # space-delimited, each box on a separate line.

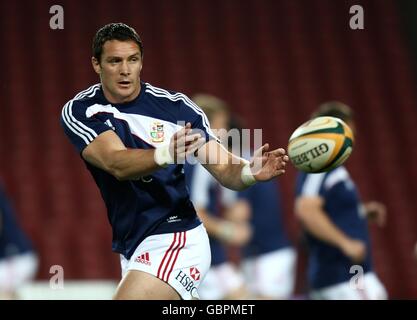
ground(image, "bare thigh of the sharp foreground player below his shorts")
xmin=113 ymin=270 xmax=180 ymax=300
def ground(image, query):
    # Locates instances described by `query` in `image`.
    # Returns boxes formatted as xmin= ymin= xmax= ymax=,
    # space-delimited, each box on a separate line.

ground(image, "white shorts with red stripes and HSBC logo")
xmin=120 ymin=224 xmax=211 ymax=300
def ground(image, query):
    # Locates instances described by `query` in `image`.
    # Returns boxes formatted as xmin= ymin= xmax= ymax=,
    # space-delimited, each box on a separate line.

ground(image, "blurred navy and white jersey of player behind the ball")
xmin=296 ymin=166 xmax=372 ymax=289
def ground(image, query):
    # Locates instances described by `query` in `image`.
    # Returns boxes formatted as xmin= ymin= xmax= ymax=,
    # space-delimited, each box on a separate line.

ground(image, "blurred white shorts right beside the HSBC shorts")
xmin=199 ymin=262 xmax=245 ymax=300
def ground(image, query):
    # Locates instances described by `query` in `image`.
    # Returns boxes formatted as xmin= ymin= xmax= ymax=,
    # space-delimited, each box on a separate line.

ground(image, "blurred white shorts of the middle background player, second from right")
xmin=242 ymin=248 xmax=297 ymax=299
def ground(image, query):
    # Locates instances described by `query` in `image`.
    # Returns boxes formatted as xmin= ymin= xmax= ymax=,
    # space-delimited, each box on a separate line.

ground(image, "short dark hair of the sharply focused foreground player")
xmin=93 ymin=22 xmax=143 ymax=62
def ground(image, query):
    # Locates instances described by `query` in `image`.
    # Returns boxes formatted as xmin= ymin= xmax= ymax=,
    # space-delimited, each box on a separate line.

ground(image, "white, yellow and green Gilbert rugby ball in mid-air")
xmin=288 ymin=117 xmax=354 ymax=173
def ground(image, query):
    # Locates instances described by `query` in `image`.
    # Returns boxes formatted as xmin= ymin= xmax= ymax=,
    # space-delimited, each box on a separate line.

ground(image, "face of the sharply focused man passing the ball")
xmin=91 ymin=40 xmax=142 ymax=103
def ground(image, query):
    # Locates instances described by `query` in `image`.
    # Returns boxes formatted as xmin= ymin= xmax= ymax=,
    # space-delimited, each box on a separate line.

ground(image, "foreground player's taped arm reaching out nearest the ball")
xmin=198 ymin=140 xmax=289 ymax=190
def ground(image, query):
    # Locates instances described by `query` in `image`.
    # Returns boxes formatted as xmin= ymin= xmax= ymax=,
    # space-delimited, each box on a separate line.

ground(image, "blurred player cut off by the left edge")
xmin=0 ymin=182 xmax=38 ymax=300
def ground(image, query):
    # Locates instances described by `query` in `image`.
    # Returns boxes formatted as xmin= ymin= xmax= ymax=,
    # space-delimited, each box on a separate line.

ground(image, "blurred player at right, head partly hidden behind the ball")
xmin=295 ymin=102 xmax=387 ymax=300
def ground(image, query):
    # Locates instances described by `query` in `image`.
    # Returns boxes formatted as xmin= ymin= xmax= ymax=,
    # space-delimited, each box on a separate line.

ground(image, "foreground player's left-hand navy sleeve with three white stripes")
xmin=61 ymin=100 xmax=111 ymax=153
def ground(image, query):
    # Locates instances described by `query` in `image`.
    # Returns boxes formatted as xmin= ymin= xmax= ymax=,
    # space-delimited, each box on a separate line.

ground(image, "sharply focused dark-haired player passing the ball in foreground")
xmin=61 ymin=23 xmax=288 ymax=299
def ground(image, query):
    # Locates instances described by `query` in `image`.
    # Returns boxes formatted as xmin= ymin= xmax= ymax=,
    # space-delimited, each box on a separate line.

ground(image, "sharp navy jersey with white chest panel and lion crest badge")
xmin=61 ymin=82 xmax=216 ymax=259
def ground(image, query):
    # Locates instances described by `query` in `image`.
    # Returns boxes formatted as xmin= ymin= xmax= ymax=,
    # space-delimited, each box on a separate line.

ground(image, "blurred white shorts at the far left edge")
xmin=0 ymin=252 xmax=39 ymax=292
